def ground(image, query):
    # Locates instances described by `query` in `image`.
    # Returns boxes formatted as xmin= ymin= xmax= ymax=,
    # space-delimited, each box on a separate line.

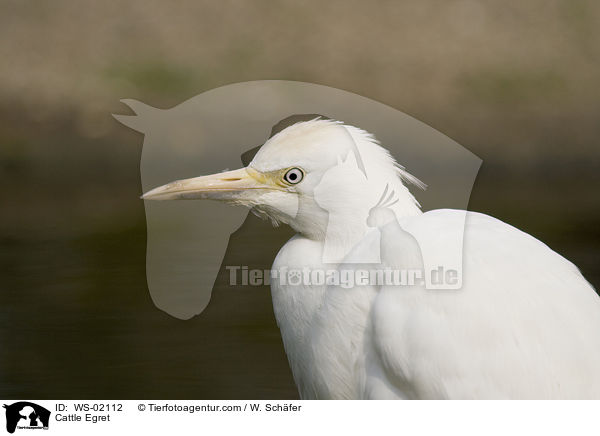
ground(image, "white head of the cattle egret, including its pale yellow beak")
xmin=142 ymin=119 xmax=423 ymax=238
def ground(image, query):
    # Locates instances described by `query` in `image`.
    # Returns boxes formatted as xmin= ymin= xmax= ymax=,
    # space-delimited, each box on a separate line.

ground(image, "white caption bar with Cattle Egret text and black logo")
xmin=2 ymin=400 xmax=600 ymax=436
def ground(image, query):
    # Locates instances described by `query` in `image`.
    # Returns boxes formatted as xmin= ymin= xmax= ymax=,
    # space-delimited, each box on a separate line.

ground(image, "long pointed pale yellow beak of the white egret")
xmin=142 ymin=167 xmax=281 ymax=201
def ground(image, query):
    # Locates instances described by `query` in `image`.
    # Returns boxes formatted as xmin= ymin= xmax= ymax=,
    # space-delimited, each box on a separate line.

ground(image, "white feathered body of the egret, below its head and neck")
xmin=272 ymin=210 xmax=600 ymax=399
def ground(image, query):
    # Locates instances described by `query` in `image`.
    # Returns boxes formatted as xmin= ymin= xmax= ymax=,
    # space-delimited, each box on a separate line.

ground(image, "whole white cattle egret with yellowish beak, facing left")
xmin=143 ymin=120 xmax=600 ymax=399
